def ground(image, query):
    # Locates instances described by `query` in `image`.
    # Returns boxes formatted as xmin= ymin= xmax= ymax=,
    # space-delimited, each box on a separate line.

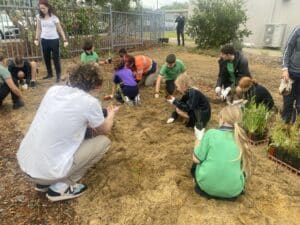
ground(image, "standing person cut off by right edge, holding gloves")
xmin=281 ymin=25 xmax=300 ymax=123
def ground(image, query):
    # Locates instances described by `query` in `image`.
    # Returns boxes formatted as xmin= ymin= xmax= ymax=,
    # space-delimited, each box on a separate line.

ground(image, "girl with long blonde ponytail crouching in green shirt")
xmin=191 ymin=106 xmax=250 ymax=200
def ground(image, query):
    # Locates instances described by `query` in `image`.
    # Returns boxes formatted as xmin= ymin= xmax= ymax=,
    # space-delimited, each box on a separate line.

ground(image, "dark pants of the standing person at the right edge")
xmin=281 ymin=72 xmax=300 ymax=123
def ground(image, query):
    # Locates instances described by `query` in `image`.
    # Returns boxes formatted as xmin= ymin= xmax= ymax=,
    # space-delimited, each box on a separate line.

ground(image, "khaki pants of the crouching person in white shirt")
xmin=31 ymin=135 xmax=111 ymax=185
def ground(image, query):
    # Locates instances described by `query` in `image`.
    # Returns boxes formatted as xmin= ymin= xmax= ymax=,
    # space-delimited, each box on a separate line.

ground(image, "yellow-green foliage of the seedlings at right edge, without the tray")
xmin=270 ymin=115 xmax=300 ymax=157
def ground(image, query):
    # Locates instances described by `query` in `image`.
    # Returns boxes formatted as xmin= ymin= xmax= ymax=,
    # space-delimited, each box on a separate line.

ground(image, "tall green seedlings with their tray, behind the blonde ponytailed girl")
xmin=243 ymin=100 xmax=271 ymax=145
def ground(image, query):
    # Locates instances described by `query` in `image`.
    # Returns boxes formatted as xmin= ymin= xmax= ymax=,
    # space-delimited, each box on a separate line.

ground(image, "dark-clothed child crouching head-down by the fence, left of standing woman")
xmin=8 ymin=56 xmax=37 ymax=89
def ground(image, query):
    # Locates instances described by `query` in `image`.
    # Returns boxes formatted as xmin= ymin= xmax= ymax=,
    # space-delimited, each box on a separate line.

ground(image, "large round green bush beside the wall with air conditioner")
xmin=187 ymin=0 xmax=251 ymax=49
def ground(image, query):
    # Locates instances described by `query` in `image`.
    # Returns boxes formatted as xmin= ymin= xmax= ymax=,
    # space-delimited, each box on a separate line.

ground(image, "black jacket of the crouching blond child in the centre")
xmin=173 ymin=88 xmax=211 ymax=130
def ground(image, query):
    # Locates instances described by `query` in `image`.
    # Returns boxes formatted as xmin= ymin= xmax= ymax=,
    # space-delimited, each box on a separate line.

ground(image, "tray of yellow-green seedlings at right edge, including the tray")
xmin=268 ymin=115 xmax=300 ymax=174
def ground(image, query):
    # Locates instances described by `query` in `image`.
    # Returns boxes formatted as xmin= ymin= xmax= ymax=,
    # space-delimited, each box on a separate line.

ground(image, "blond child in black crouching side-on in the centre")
xmin=167 ymin=73 xmax=211 ymax=140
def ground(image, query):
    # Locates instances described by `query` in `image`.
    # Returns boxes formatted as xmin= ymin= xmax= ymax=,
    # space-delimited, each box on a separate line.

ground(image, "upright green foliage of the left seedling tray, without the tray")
xmin=243 ymin=99 xmax=270 ymax=135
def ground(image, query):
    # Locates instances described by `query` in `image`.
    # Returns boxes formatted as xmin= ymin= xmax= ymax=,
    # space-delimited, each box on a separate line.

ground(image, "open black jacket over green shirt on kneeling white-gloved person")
xmin=216 ymin=51 xmax=251 ymax=88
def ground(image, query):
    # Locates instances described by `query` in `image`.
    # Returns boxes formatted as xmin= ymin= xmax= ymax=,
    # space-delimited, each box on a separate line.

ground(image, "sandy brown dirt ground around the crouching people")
xmin=0 ymin=46 xmax=300 ymax=225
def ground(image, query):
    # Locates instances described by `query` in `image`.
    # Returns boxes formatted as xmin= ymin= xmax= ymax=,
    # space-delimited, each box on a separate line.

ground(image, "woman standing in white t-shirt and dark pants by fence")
xmin=34 ymin=0 xmax=68 ymax=82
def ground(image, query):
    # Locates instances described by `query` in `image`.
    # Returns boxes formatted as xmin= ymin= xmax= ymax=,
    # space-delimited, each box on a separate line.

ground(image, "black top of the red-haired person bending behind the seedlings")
xmin=244 ymin=84 xmax=274 ymax=110
